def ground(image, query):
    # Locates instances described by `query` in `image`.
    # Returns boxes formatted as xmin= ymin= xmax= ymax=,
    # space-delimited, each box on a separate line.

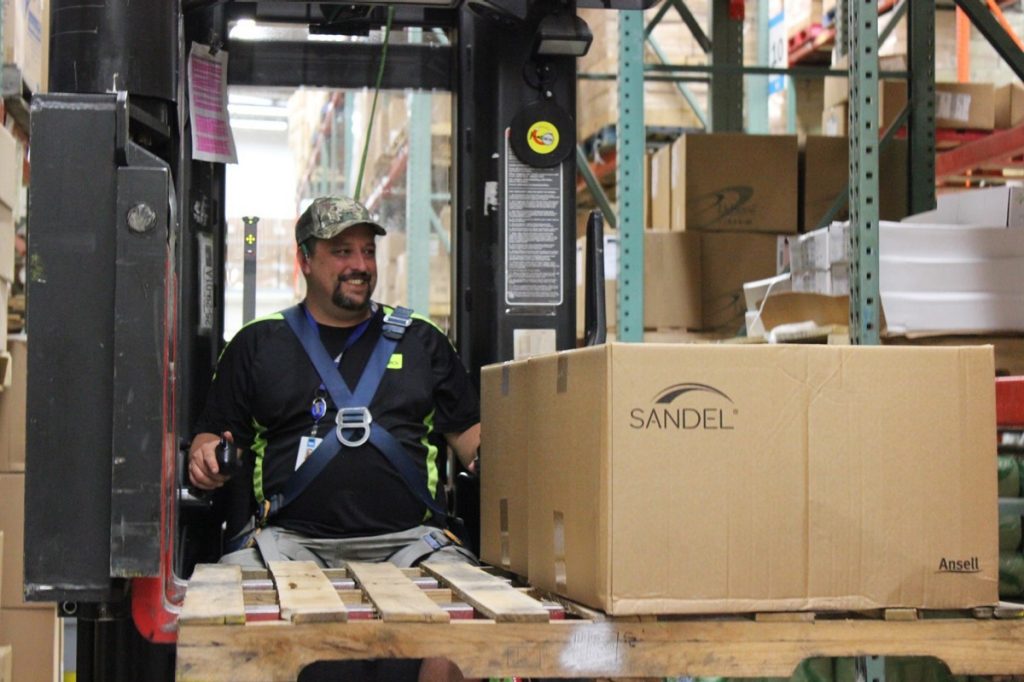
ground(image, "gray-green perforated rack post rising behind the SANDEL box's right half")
xmin=847 ymin=2 xmax=880 ymax=345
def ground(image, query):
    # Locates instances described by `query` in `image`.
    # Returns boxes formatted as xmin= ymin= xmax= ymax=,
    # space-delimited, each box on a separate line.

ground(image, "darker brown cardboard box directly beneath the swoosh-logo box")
xmin=700 ymin=232 xmax=778 ymax=335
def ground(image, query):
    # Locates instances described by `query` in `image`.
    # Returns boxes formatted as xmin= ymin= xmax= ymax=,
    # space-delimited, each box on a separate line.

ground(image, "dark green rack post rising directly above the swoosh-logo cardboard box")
xmin=711 ymin=0 xmax=743 ymax=132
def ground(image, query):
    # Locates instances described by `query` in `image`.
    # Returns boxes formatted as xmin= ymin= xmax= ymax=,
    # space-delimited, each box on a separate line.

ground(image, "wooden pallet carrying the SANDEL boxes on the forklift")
xmin=176 ymin=562 xmax=1024 ymax=682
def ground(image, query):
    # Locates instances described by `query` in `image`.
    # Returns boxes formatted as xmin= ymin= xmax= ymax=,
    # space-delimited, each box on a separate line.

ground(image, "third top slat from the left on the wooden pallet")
xmin=348 ymin=561 xmax=449 ymax=623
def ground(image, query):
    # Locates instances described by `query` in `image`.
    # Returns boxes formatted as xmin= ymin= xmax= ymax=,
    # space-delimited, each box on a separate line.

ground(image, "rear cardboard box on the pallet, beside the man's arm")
xmin=480 ymin=360 xmax=530 ymax=578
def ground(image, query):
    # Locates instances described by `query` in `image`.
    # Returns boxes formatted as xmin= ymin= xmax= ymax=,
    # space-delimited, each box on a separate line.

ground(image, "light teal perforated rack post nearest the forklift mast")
xmin=615 ymin=10 xmax=645 ymax=342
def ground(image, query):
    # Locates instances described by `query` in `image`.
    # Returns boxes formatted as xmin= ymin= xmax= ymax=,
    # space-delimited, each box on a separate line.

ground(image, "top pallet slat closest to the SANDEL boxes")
xmin=421 ymin=561 xmax=548 ymax=623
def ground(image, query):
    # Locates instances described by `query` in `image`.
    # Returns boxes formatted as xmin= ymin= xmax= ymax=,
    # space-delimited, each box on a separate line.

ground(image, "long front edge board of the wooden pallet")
xmin=175 ymin=619 xmax=1024 ymax=682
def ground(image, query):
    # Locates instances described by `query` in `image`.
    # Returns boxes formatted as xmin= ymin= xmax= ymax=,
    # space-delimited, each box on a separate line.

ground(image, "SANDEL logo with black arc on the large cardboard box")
xmin=630 ymin=382 xmax=739 ymax=431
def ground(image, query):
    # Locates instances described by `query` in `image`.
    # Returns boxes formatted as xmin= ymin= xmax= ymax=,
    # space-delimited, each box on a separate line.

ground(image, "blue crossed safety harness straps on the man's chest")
xmin=259 ymin=305 xmax=447 ymax=525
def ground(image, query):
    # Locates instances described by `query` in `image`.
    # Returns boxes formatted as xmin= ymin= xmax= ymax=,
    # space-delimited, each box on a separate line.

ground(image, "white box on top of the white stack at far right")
xmin=903 ymin=185 xmax=1024 ymax=228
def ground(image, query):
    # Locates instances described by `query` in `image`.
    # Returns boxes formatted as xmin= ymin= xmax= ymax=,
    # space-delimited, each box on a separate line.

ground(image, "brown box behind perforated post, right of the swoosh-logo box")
xmin=800 ymin=135 xmax=908 ymax=230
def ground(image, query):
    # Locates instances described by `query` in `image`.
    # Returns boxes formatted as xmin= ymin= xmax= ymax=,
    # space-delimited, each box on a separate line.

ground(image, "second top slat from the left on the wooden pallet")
xmin=269 ymin=561 xmax=348 ymax=623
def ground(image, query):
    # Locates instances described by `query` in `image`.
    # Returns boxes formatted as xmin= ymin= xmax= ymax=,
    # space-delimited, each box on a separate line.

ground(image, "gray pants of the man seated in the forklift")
xmin=220 ymin=525 xmax=476 ymax=568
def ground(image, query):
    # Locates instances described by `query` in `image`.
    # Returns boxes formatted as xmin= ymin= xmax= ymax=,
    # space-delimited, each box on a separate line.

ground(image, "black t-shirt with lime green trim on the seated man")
xmin=198 ymin=308 xmax=480 ymax=538
